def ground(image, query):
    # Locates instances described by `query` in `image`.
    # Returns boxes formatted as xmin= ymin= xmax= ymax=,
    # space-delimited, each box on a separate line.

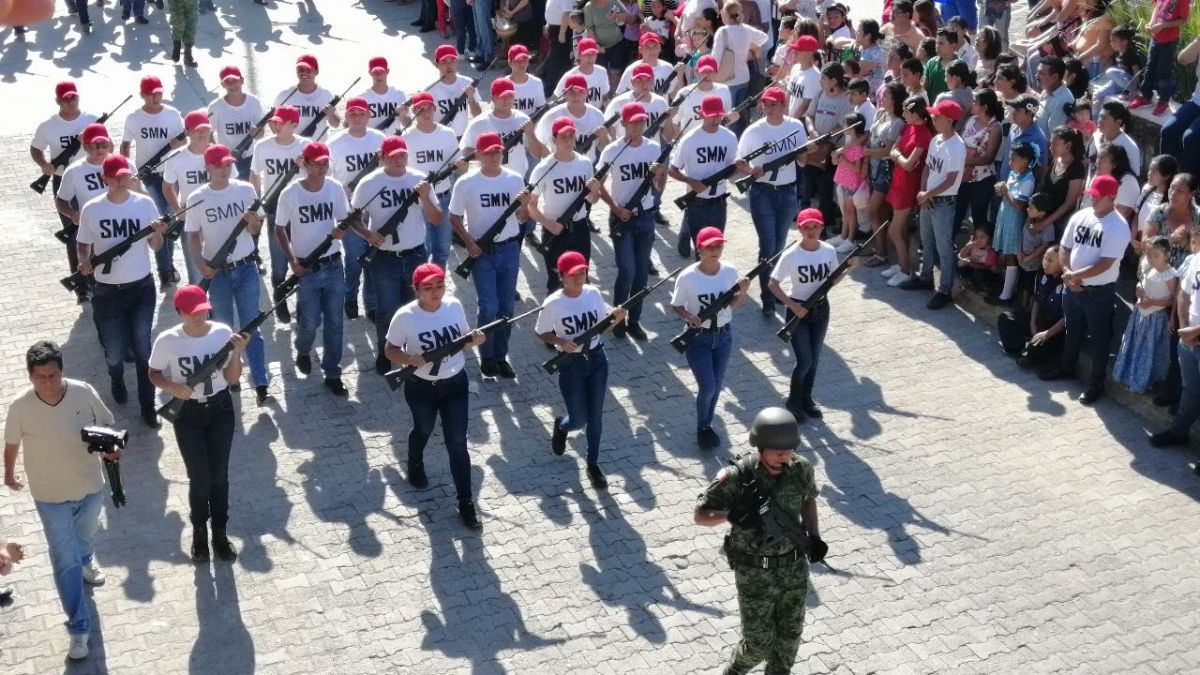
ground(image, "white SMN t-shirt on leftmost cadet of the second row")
xmin=76 ymin=192 xmax=158 ymax=285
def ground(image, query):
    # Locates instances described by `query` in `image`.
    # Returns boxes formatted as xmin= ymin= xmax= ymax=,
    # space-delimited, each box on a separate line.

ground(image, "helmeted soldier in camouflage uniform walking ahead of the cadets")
xmin=695 ymin=407 xmax=829 ymax=675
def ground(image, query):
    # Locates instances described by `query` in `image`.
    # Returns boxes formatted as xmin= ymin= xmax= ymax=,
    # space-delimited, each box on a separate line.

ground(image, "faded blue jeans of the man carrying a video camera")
xmin=34 ymin=485 xmax=104 ymax=635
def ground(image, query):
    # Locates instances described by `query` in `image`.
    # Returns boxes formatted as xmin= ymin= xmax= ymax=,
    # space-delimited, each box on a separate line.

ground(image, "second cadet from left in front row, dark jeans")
xmin=386 ymin=263 xmax=485 ymax=530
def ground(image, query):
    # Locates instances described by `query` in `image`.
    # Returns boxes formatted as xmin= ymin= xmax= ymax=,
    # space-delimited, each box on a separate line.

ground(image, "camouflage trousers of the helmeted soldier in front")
xmin=725 ymin=560 xmax=809 ymax=675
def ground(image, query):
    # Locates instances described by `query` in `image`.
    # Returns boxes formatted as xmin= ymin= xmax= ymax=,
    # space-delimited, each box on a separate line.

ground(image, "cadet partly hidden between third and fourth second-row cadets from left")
xmin=329 ymin=96 xmax=384 ymax=322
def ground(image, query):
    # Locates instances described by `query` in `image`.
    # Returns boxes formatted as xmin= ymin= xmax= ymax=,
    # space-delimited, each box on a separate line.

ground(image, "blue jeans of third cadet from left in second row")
xmin=296 ymin=259 xmax=346 ymax=378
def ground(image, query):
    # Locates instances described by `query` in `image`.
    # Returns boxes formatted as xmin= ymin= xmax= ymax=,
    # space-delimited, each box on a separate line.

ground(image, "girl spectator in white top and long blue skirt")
xmin=1112 ymin=237 xmax=1178 ymax=394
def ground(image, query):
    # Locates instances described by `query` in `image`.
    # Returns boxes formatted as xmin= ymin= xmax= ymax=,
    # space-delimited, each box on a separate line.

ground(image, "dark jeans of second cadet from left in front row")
xmin=404 ymin=370 xmax=472 ymax=502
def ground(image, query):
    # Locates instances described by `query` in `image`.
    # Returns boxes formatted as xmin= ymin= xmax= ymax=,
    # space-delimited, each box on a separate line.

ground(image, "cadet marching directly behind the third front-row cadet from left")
xmin=527 ymin=118 xmax=600 ymax=293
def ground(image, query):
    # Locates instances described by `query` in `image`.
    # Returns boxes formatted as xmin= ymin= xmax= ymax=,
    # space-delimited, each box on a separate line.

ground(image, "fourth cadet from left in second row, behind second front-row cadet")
xmin=350 ymin=136 xmax=442 ymax=375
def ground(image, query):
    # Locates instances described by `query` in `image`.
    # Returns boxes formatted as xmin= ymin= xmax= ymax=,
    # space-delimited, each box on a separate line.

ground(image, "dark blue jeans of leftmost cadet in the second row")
xmin=91 ymin=274 xmax=157 ymax=410
